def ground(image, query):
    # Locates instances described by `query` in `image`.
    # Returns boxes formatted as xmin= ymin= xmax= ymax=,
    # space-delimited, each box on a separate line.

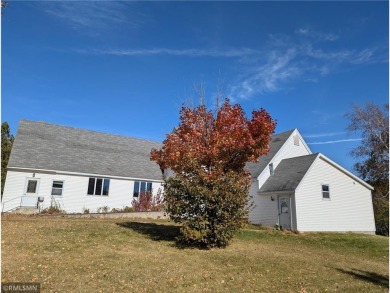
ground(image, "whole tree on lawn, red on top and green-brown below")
xmin=151 ymin=99 xmax=276 ymax=247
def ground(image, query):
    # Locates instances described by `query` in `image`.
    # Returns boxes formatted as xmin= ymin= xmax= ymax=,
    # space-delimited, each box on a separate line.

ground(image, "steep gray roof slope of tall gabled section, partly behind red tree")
xmin=245 ymin=129 xmax=295 ymax=178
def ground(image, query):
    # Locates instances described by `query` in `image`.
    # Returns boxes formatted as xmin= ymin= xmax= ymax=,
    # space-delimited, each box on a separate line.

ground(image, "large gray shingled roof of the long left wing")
xmin=8 ymin=120 xmax=162 ymax=180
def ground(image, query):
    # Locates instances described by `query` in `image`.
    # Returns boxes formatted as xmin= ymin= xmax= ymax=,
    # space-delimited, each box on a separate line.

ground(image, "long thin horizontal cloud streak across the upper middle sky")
xmin=73 ymin=48 xmax=260 ymax=57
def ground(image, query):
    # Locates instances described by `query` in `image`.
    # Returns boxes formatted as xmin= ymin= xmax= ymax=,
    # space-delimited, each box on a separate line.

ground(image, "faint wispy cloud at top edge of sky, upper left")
xmin=38 ymin=1 xmax=147 ymax=33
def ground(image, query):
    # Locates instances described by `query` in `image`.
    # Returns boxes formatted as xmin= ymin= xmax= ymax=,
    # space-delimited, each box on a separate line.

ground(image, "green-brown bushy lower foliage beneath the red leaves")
xmin=164 ymin=172 xmax=249 ymax=248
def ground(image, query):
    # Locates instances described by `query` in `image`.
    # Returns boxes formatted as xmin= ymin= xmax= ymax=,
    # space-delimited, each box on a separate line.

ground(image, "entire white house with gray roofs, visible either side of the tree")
xmin=2 ymin=120 xmax=375 ymax=233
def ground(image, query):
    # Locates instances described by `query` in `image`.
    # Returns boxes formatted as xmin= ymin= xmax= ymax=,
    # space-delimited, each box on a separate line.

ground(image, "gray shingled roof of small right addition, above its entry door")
xmin=259 ymin=153 xmax=318 ymax=192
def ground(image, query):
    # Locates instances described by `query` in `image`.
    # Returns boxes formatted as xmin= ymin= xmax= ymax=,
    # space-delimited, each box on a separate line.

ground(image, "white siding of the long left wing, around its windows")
xmin=3 ymin=171 xmax=161 ymax=213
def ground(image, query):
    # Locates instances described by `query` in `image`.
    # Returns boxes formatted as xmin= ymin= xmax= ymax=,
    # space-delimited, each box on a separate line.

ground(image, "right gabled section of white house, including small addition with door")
xmin=247 ymin=129 xmax=375 ymax=234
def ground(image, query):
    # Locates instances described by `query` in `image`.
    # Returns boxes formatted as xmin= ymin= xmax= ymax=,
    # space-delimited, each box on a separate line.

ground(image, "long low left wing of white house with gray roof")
xmin=2 ymin=120 xmax=162 ymax=213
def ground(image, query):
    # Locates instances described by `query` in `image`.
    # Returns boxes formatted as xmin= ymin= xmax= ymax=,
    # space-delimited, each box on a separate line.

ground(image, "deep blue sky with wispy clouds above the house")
xmin=1 ymin=1 xmax=389 ymax=170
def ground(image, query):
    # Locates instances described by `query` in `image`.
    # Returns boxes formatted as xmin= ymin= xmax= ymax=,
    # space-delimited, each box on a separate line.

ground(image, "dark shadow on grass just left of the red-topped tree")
xmin=116 ymin=222 xmax=180 ymax=241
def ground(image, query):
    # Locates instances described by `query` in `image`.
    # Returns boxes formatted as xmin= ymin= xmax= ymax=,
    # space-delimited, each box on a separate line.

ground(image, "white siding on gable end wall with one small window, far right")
xmin=295 ymin=157 xmax=375 ymax=232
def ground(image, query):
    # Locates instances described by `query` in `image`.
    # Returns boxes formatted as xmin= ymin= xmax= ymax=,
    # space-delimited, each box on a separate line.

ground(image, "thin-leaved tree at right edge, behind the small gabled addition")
xmin=347 ymin=103 xmax=389 ymax=235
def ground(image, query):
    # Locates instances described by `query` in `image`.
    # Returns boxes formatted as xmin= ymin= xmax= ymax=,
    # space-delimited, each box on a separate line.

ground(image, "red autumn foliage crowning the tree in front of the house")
xmin=151 ymin=99 xmax=276 ymax=176
